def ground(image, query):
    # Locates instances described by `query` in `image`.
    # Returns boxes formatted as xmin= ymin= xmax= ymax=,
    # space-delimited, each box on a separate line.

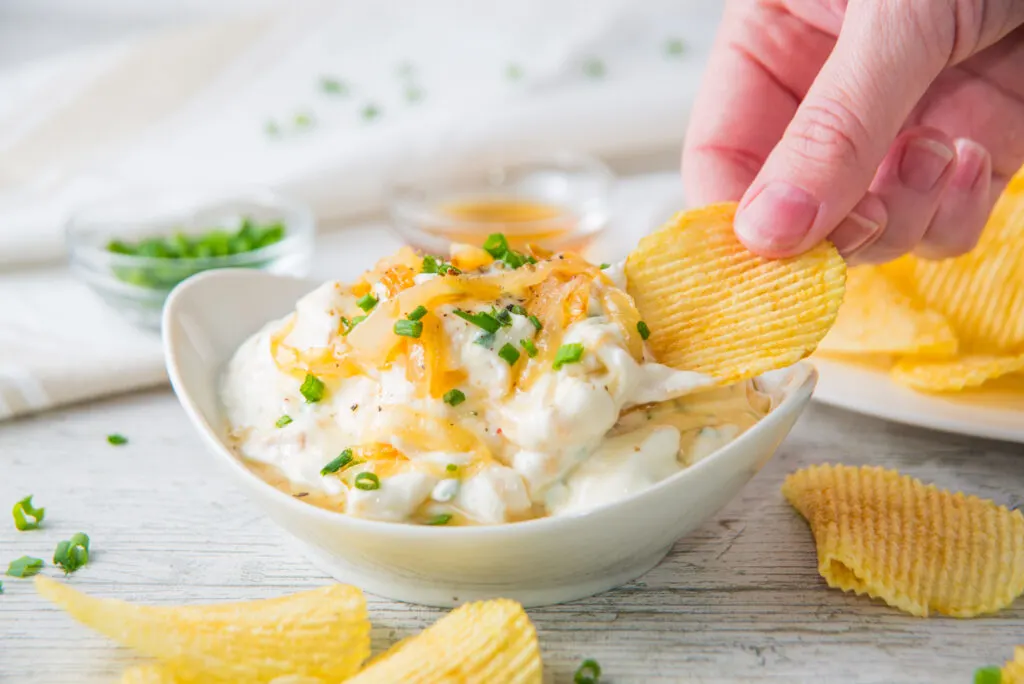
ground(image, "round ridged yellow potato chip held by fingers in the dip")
xmin=626 ymin=203 xmax=846 ymax=384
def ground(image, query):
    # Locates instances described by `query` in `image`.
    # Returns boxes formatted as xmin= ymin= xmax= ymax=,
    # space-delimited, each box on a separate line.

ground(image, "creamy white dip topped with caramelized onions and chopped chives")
xmin=221 ymin=242 xmax=770 ymax=524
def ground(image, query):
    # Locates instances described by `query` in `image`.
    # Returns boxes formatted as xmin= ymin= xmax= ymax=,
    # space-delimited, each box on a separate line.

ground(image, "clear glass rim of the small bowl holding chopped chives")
xmin=63 ymin=187 xmax=316 ymax=270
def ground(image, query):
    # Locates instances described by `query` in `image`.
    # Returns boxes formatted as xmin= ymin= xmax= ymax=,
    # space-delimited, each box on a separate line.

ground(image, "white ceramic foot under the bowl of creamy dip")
xmin=291 ymin=538 xmax=672 ymax=608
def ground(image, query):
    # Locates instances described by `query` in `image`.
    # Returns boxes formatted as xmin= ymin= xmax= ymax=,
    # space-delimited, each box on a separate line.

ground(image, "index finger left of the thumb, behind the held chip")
xmin=682 ymin=0 xmax=842 ymax=206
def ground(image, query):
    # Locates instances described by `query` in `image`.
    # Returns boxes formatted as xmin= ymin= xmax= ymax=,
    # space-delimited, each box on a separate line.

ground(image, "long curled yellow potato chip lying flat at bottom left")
xmin=36 ymin=575 xmax=370 ymax=684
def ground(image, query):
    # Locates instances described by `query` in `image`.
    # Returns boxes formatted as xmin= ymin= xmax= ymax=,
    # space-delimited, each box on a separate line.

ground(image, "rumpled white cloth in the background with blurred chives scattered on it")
xmin=0 ymin=0 xmax=721 ymax=266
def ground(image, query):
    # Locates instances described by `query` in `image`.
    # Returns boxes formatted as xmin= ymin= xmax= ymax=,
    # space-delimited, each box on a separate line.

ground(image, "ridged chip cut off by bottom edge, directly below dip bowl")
xmin=347 ymin=599 xmax=542 ymax=684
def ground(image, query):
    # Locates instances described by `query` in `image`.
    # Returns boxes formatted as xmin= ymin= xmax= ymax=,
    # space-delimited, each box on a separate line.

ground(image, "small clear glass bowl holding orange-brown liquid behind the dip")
xmin=388 ymin=152 xmax=615 ymax=254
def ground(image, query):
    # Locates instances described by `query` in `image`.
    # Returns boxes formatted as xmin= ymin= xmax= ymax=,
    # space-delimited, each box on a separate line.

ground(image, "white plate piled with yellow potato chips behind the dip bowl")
xmin=815 ymin=169 xmax=1024 ymax=442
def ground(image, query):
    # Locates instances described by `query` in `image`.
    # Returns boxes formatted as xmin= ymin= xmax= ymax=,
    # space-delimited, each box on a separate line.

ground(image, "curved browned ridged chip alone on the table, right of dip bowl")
xmin=782 ymin=465 xmax=1024 ymax=617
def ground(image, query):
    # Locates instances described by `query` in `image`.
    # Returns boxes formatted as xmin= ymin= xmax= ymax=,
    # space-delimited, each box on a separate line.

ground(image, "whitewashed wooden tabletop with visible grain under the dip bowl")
xmin=0 ymin=390 xmax=1024 ymax=684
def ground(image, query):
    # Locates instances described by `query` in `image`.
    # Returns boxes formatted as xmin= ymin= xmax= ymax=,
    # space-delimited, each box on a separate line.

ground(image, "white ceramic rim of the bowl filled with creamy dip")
xmin=162 ymin=269 xmax=818 ymax=540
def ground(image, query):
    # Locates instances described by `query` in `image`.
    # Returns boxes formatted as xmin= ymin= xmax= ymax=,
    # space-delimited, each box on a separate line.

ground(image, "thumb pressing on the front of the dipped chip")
xmin=735 ymin=0 xmax=955 ymax=257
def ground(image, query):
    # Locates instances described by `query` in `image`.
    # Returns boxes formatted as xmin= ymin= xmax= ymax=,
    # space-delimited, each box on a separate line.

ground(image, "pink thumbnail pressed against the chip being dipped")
xmin=734 ymin=180 xmax=821 ymax=252
